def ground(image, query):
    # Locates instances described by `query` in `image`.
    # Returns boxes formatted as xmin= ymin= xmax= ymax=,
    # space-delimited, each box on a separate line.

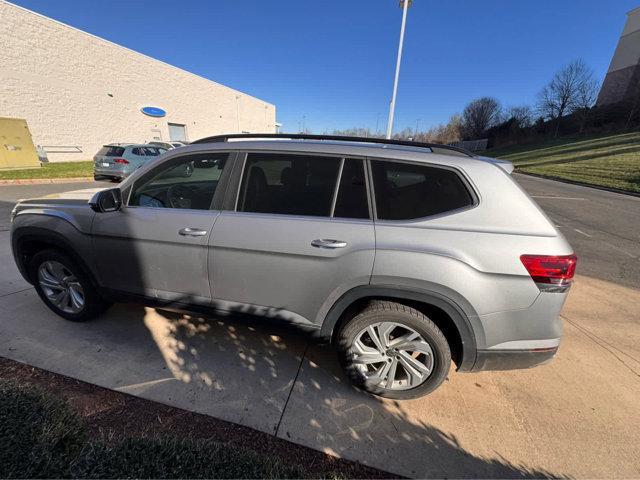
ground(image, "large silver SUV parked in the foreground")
xmin=7 ymin=135 xmax=576 ymax=399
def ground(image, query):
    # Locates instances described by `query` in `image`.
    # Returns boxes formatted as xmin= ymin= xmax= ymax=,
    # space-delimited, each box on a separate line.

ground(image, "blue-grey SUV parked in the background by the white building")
xmin=93 ymin=143 xmax=167 ymax=182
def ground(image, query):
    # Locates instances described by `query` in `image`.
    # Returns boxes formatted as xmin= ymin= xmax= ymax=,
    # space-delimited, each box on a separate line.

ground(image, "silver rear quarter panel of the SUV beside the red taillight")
xmin=371 ymin=161 xmax=572 ymax=348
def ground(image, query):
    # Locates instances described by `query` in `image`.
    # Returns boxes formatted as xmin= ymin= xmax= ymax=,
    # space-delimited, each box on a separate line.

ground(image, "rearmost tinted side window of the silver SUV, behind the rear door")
xmin=371 ymin=160 xmax=473 ymax=220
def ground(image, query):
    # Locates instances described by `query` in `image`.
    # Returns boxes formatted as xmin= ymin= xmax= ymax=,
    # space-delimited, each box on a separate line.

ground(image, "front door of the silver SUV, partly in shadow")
xmin=92 ymin=153 xmax=234 ymax=305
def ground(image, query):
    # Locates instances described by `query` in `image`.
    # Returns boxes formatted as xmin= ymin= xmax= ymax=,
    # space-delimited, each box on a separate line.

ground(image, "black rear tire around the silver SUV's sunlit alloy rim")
xmin=336 ymin=300 xmax=451 ymax=399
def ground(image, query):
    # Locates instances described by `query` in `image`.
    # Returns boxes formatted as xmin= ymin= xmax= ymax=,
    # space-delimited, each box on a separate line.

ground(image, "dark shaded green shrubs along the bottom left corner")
xmin=0 ymin=380 xmax=338 ymax=478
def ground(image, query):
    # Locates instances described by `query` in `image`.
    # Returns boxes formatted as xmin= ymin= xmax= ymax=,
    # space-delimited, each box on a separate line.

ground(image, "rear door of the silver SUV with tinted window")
xmin=209 ymin=153 xmax=375 ymax=326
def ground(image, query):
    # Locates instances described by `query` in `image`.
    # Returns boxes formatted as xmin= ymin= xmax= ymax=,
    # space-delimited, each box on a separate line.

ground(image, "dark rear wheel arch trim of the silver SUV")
xmin=320 ymin=285 xmax=477 ymax=371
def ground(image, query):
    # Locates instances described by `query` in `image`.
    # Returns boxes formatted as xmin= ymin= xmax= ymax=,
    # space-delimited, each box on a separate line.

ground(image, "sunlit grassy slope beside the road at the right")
xmin=486 ymin=132 xmax=640 ymax=193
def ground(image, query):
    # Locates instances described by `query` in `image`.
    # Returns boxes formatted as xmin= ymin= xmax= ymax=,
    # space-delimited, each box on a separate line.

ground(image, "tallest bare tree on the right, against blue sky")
xmin=538 ymin=59 xmax=596 ymax=136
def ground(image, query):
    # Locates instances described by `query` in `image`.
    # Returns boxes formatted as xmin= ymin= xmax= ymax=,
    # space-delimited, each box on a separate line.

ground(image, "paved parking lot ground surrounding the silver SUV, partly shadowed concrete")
xmin=0 ymin=176 xmax=640 ymax=478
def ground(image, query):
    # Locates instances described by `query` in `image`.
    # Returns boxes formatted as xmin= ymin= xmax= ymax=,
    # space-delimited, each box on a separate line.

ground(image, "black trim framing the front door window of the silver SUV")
xmin=125 ymin=150 xmax=237 ymax=212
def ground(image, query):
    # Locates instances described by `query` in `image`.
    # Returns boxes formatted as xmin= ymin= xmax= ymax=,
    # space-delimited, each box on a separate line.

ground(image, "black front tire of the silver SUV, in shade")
xmin=29 ymin=249 xmax=111 ymax=322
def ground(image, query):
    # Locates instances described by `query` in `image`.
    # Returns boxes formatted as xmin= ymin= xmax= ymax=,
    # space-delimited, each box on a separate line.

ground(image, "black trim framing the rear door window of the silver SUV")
xmin=228 ymin=149 xmax=374 ymax=222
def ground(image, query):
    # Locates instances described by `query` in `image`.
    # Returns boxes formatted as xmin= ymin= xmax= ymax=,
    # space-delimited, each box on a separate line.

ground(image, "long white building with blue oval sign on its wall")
xmin=0 ymin=0 xmax=276 ymax=161
